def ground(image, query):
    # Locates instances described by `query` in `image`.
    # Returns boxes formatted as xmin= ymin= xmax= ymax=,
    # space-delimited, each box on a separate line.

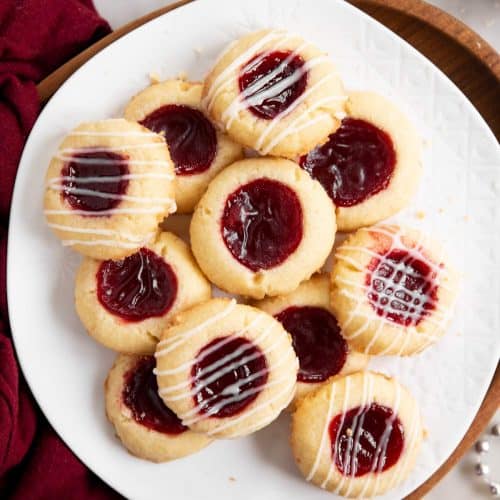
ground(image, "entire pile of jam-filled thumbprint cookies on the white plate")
xmin=45 ymin=30 xmax=457 ymax=497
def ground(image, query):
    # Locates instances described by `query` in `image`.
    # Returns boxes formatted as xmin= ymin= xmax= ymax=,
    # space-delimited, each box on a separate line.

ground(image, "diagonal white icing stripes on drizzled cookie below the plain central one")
xmin=154 ymin=299 xmax=295 ymax=434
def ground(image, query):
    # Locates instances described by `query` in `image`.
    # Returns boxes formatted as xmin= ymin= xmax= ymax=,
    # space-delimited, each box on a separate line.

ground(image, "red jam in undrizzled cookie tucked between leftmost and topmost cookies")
xmin=141 ymin=104 xmax=217 ymax=175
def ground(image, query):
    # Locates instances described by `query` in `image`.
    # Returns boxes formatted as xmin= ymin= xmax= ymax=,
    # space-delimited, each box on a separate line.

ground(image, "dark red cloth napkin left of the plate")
xmin=0 ymin=0 xmax=122 ymax=500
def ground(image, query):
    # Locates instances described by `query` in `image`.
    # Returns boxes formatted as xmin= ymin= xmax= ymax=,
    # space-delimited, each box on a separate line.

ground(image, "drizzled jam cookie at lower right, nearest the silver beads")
xmin=291 ymin=372 xmax=423 ymax=498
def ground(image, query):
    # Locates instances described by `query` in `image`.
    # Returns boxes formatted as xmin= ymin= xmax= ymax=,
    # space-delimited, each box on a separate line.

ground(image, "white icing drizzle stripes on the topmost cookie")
xmin=203 ymin=31 xmax=347 ymax=154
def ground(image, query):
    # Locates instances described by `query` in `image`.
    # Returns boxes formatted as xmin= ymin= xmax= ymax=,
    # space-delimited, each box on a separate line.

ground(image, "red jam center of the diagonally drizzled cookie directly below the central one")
xmin=191 ymin=336 xmax=268 ymax=418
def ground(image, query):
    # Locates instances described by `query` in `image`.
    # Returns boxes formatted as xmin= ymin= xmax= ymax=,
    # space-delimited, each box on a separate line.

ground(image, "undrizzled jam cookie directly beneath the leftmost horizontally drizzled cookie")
xmin=75 ymin=232 xmax=211 ymax=354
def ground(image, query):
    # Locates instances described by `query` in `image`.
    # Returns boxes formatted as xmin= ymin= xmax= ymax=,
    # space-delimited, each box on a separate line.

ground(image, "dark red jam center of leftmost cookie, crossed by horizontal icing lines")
xmin=61 ymin=150 xmax=129 ymax=211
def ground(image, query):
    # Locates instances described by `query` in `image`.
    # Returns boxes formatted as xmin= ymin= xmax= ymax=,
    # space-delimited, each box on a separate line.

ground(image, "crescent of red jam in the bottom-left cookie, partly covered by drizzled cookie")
xmin=122 ymin=356 xmax=187 ymax=434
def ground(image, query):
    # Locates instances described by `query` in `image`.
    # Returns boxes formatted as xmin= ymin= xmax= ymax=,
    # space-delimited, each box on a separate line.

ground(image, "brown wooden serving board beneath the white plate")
xmin=38 ymin=0 xmax=500 ymax=500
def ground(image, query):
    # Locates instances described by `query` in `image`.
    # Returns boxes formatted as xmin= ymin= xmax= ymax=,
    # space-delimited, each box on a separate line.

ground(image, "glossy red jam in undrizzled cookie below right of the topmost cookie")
xmin=299 ymin=118 xmax=396 ymax=207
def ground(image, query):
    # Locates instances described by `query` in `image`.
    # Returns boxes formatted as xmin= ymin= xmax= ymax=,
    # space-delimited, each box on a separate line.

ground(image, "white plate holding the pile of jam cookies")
xmin=8 ymin=0 xmax=500 ymax=500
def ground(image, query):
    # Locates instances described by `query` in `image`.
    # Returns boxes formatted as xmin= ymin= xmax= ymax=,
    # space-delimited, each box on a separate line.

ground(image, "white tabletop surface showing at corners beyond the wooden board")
xmin=94 ymin=0 xmax=500 ymax=500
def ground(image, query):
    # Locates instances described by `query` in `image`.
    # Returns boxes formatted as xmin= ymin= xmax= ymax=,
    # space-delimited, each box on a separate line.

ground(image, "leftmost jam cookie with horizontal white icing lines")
xmin=44 ymin=119 xmax=175 ymax=259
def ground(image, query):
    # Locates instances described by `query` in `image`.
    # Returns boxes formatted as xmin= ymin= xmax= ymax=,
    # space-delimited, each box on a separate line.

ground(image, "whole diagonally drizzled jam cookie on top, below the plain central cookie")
xmin=155 ymin=299 xmax=298 ymax=438
